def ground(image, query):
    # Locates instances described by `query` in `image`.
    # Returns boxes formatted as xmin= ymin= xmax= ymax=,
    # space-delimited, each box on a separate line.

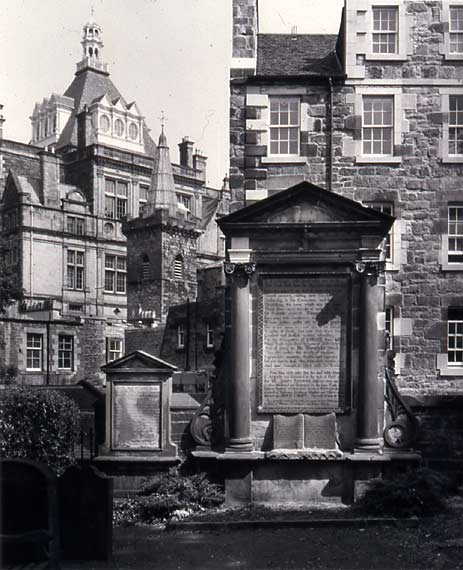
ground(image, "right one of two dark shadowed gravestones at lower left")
xmin=58 ymin=466 xmax=113 ymax=560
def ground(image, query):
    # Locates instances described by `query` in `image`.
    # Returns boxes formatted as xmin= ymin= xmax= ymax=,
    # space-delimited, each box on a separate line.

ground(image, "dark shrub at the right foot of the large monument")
xmin=357 ymin=468 xmax=451 ymax=517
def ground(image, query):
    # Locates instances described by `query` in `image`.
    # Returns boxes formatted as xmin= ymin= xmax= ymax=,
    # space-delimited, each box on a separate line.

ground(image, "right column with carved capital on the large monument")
xmin=355 ymin=262 xmax=381 ymax=452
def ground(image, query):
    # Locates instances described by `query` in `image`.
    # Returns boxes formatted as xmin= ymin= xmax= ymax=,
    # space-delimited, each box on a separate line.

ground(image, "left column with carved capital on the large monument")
xmin=225 ymin=263 xmax=255 ymax=451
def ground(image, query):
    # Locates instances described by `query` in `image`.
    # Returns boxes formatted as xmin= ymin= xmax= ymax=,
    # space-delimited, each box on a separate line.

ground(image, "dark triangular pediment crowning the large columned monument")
xmin=218 ymin=182 xmax=393 ymax=227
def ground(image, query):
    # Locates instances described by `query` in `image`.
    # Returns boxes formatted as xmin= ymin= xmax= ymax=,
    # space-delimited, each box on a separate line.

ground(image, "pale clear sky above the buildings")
xmin=0 ymin=0 xmax=343 ymax=186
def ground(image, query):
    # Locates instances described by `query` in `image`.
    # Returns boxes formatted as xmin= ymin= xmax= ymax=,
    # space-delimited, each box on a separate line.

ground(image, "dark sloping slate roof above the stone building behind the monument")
xmin=257 ymin=34 xmax=344 ymax=76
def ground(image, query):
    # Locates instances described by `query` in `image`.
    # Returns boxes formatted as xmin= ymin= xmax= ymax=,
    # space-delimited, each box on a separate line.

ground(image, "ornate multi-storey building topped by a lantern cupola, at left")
xmin=0 ymin=17 xmax=229 ymax=384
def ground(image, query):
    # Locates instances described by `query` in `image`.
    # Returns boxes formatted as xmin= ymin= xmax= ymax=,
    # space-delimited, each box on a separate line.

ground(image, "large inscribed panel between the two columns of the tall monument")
xmin=258 ymin=274 xmax=350 ymax=413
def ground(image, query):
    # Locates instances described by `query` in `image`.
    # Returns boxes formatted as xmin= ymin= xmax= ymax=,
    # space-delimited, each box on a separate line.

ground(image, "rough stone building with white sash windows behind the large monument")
xmin=230 ymin=0 xmax=463 ymax=453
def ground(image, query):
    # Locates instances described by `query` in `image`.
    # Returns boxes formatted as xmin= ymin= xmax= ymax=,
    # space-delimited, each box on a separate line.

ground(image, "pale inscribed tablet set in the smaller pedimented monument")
xmin=112 ymin=384 xmax=161 ymax=451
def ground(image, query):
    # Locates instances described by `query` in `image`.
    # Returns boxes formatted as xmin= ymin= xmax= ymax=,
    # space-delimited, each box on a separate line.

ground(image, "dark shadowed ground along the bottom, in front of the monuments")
xmin=63 ymin=514 xmax=463 ymax=570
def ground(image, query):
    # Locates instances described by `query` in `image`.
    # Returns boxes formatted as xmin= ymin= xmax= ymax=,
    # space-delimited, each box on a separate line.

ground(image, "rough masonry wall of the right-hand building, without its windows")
xmin=230 ymin=0 xmax=463 ymax=394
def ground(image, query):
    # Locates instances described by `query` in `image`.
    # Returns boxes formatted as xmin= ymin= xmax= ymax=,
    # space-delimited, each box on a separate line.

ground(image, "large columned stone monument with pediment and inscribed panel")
xmin=195 ymin=182 xmax=418 ymax=503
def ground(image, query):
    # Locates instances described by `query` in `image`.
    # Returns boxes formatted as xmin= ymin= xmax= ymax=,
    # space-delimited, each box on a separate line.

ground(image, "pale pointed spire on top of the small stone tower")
xmin=145 ymin=125 xmax=177 ymax=217
